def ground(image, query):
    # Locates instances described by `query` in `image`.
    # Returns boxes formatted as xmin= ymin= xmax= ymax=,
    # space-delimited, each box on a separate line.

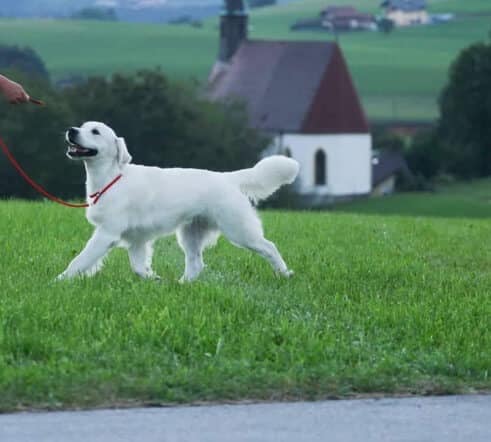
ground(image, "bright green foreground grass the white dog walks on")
xmin=0 ymin=201 xmax=491 ymax=411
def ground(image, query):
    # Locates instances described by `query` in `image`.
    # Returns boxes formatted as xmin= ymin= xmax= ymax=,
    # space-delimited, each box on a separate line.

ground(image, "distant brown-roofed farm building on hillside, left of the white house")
xmin=321 ymin=6 xmax=377 ymax=31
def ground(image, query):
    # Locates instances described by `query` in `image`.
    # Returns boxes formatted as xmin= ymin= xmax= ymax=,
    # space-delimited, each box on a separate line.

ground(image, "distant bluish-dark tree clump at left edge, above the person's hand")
xmin=0 ymin=45 xmax=49 ymax=79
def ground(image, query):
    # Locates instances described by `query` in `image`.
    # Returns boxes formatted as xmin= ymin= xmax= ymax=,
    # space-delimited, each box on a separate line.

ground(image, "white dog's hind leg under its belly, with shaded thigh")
xmin=176 ymin=218 xmax=219 ymax=282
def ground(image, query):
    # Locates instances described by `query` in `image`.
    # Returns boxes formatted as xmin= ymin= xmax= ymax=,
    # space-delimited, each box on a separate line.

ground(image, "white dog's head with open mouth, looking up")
xmin=65 ymin=121 xmax=131 ymax=166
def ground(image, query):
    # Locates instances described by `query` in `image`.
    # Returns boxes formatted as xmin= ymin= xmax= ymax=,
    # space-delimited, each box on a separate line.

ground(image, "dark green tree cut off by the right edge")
xmin=439 ymin=37 xmax=491 ymax=178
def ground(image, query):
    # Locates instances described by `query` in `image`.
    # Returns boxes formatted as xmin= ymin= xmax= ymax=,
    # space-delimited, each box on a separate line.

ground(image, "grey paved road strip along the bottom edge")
xmin=0 ymin=396 xmax=491 ymax=442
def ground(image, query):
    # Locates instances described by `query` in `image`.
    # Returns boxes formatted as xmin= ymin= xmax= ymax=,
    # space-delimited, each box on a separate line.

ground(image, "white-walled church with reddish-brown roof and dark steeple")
xmin=208 ymin=0 xmax=372 ymax=205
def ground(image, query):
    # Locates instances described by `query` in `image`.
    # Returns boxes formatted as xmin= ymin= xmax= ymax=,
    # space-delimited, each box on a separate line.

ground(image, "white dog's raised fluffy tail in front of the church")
xmin=228 ymin=155 xmax=300 ymax=202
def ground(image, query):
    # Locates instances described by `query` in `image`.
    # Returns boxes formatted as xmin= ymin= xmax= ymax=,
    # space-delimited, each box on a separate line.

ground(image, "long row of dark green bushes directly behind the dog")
xmin=0 ymin=71 xmax=269 ymax=197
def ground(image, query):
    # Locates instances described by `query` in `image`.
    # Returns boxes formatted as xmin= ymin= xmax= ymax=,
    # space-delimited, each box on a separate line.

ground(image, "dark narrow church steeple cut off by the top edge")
xmin=218 ymin=0 xmax=248 ymax=63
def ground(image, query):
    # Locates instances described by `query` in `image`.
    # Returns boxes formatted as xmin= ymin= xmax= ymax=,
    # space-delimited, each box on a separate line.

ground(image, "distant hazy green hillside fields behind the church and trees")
xmin=0 ymin=0 xmax=491 ymax=119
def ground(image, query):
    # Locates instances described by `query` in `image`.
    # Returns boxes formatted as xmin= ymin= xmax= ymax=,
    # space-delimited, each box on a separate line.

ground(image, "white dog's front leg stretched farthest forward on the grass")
xmin=56 ymin=229 xmax=119 ymax=281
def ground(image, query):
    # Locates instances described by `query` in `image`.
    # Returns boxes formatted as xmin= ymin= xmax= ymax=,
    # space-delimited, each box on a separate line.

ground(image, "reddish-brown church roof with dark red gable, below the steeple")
xmin=208 ymin=40 xmax=369 ymax=133
